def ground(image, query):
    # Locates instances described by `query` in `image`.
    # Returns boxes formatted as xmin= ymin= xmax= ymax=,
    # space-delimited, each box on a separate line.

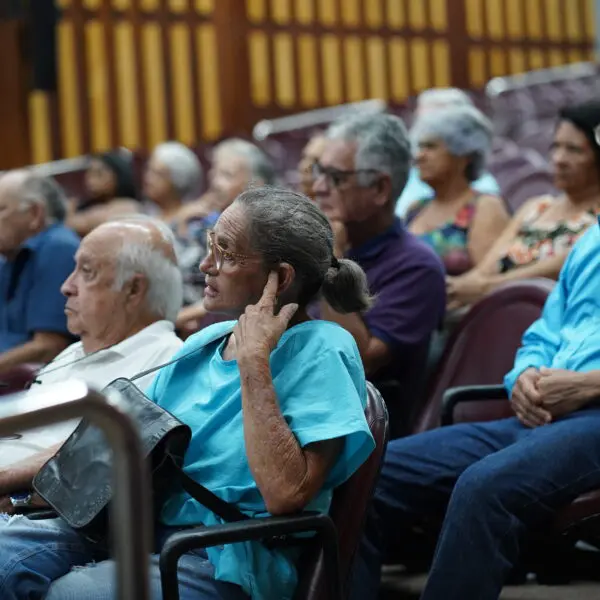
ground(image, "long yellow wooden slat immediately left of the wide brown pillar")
xmin=196 ymin=25 xmax=223 ymax=140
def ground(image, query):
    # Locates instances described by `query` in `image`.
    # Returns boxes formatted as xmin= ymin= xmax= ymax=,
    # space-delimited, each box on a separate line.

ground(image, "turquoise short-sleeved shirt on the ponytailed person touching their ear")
xmin=148 ymin=321 xmax=374 ymax=600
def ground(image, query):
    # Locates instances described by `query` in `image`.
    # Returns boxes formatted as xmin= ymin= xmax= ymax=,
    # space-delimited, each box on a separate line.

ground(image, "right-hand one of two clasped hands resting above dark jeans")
xmin=537 ymin=367 xmax=590 ymax=418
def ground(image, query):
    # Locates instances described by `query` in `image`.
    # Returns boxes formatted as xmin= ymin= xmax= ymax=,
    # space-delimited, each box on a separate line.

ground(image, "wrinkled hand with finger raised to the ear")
xmin=233 ymin=271 xmax=298 ymax=363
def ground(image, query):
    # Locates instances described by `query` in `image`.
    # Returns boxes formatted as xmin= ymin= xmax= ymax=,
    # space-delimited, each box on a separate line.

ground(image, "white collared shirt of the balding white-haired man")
xmin=0 ymin=321 xmax=183 ymax=467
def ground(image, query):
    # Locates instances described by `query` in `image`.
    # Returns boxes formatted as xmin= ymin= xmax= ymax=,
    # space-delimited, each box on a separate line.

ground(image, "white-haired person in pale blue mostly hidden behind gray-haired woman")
xmin=396 ymin=88 xmax=500 ymax=217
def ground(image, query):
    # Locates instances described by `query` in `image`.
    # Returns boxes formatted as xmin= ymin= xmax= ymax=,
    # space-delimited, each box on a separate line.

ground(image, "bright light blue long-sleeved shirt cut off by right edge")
xmin=504 ymin=225 xmax=600 ymax=394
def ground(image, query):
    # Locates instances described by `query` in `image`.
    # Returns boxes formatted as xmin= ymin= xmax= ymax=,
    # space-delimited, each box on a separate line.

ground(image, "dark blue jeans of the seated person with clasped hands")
xmin=353 ymin=405 xmax=600 ymax=600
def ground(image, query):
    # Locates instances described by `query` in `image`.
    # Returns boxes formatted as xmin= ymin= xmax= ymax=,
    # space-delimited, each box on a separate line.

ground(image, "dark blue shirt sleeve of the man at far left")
xmin=25 ymin=238 xmax=77 ymax=335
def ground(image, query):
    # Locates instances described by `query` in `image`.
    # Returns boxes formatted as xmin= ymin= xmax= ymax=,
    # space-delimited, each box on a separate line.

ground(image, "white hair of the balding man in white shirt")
xmin=111 ymin=215 xmax=183 ymax=322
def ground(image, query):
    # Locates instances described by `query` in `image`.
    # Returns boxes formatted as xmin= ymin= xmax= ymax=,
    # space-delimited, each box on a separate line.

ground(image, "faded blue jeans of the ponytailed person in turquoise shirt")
xmin=0 ymin=515 xmax=248 ymax=600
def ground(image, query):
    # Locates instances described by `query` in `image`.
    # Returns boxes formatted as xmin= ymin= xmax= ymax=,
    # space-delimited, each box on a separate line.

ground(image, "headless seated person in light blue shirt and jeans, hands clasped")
xmin=356 ymin=221 xmax=600 ymax=600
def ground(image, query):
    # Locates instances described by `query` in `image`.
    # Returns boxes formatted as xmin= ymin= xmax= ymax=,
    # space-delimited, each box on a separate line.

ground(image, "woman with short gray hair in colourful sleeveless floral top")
xmin=406 ymin=105 xmax=509 ymax=274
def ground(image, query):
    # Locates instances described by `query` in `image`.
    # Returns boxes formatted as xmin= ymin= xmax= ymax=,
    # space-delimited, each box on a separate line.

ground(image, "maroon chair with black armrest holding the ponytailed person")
xmin=160 ymin=384 xmax=388 ymax=600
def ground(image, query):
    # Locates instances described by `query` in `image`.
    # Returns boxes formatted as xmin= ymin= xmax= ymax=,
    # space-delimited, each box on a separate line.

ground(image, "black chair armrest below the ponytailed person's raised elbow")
xmin=159 ymin=513 xmax=342 ymax=600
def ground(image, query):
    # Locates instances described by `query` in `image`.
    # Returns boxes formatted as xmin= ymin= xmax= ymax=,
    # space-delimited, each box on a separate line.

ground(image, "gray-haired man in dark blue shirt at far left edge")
xmin=0 ymin=171 xmax=79 ymax=372
